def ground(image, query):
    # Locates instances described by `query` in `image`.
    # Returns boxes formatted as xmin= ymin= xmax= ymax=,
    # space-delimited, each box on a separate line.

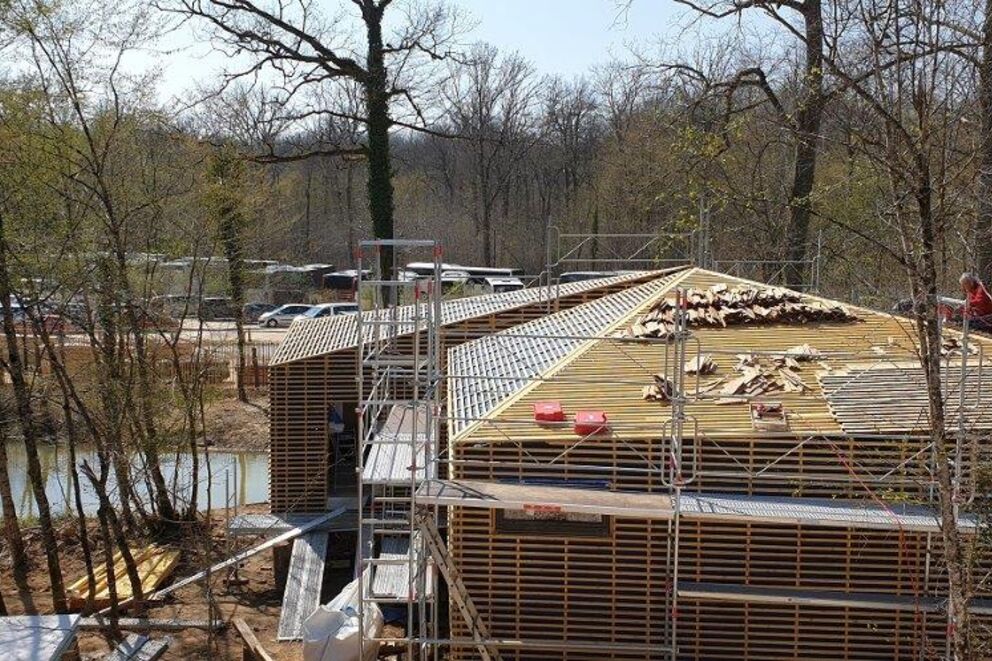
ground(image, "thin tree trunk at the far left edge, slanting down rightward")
xmin=0 ymin=210 xmax=67 ymax=613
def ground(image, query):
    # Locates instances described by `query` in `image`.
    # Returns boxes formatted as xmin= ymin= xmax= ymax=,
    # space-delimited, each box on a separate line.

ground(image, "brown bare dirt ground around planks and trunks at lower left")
xmin=0 ymin=505 xmax=366 ymax=660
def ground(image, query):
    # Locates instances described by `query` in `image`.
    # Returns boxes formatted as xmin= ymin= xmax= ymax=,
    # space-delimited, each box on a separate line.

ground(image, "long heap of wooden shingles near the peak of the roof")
xmin=625 ymin=285 xmax=857 ymax=339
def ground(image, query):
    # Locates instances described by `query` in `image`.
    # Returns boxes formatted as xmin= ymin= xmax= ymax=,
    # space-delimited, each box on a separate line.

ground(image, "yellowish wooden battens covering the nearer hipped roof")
xmin=448 ymin=268 xmax=992 ymax=444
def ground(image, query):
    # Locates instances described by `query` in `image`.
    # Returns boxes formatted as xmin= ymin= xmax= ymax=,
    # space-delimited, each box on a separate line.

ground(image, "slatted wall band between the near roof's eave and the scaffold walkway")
xmin=457 ymin=436 xmax=940 ymax=499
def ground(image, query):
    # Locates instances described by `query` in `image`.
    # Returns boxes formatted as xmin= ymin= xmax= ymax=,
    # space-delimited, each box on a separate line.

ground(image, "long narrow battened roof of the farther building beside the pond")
xmin=270 ymin=266 xmax=687 ymax=365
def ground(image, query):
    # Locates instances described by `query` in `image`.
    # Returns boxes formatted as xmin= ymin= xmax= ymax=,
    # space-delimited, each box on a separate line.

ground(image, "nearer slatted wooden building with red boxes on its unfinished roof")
xmin=430 ymin=268 xmax=992 ymax=661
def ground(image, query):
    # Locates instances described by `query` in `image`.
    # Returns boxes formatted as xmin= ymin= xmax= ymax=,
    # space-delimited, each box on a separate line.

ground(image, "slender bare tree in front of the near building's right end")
xmin=824 ymin=2 xmax=978 ymax=661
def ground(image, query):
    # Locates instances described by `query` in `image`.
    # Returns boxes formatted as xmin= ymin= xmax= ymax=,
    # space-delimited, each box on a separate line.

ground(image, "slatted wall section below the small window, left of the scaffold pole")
xmin=449 ymin=508 xmax=669 ymax=659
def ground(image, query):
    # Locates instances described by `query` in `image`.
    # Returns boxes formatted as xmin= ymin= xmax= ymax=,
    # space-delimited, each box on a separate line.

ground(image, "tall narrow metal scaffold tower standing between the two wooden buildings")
xmin=356 ymin=239 xmax=441 ymax=659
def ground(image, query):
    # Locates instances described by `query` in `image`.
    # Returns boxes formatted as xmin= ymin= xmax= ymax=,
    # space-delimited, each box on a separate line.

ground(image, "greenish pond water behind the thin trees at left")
xmin=1 ymin=441 xmax=269 ymax=518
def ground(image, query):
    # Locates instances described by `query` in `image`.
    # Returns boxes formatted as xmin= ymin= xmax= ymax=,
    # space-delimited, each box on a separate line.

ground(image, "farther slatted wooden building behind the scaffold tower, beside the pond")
xmin=269 ymin=272 xmax=672 ymax=513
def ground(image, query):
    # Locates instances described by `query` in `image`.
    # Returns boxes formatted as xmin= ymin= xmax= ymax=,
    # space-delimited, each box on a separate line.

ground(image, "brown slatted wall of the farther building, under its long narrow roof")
xmin=269 ymin=278 xmax=644 ymax=513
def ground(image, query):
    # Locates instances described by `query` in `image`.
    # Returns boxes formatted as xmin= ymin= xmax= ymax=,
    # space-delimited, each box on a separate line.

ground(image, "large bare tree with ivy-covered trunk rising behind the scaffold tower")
xmin=170 ymin=0 xmax=455 ymax=272
